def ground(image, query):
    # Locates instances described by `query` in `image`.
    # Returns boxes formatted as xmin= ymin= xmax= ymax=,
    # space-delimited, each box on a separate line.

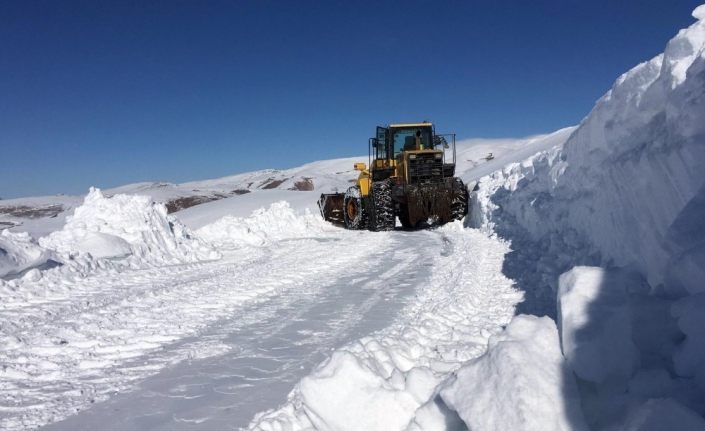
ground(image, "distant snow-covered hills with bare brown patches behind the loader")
xmin=0 ymin=128 xmax=571 ymax=238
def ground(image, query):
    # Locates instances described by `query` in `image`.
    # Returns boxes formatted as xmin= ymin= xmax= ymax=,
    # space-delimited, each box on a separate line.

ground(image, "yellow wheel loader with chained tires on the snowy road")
xmin=318 ymin=122 xmax=468 ymax=231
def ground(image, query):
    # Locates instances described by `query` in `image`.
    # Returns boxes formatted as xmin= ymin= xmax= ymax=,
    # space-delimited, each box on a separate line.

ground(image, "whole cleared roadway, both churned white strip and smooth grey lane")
xmin=0 ymin=223 xmax=512 ymax=429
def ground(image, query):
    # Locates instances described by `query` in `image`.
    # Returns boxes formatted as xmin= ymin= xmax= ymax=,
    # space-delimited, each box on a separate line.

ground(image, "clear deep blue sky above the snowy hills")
xmin=0 ymin=0 xmax=699 ymax=198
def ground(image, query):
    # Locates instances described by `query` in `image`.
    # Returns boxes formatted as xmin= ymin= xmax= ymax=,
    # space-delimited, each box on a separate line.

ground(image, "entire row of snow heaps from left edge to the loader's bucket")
xmin=0 ymin=188 xmax=324 ymax=291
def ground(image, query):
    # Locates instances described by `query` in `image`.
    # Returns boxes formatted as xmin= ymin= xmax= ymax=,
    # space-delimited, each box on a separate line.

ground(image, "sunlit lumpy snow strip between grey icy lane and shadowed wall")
xmin=249 ymin=226 xmax=521 ymax=431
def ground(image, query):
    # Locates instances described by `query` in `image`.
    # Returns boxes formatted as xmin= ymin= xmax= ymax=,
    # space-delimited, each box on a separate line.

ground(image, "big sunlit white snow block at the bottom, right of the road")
xmin=440 ymin=315 xmax=587 ymax=431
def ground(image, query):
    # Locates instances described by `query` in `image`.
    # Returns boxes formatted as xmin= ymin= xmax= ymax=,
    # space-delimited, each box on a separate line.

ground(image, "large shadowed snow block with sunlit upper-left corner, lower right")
xmin=558 ymin=266 xmax=705 ymax=429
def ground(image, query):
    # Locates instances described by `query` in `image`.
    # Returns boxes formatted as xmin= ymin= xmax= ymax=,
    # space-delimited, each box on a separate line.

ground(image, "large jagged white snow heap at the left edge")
xmin=0 ymin=188 xmax=220 ymax=286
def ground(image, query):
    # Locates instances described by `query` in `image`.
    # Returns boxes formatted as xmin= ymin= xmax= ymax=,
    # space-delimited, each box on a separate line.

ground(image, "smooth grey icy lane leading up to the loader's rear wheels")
xmin=40 ymin=232 xmax=442 ymax=430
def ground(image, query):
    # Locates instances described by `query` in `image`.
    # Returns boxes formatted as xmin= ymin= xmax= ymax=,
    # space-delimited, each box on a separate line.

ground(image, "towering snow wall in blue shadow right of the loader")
xmin=475 ymin=5 xmax=705 ymax=292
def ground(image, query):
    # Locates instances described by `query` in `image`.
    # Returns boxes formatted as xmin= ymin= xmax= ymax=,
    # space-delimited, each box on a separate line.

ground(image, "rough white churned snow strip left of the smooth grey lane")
xmin=0 ymin=232 xmax=388 ymax=430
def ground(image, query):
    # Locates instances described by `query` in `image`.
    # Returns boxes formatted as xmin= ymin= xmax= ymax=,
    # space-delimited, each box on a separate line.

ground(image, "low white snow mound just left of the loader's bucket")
xmin=196 ymin=201 xmax=337 ymax=246
